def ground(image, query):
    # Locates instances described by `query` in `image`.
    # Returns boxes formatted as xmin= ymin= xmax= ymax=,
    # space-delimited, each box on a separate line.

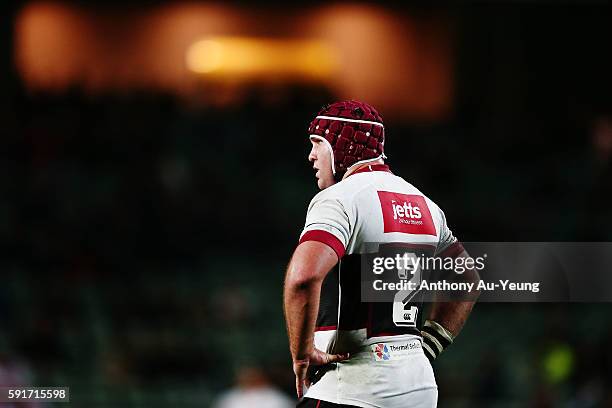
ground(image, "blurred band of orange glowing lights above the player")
xmin=14 ymin=0 xmax=453 ymax=119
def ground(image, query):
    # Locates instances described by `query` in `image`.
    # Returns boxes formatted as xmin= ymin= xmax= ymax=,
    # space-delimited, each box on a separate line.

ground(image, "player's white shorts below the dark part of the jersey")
xmin=305 ymin=336 xmax=438 ymax=408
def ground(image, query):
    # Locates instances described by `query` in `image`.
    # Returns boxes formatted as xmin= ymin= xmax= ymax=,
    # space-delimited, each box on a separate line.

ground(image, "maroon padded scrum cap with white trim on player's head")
xmin=308 ymin=101 xmax=386 ymax=179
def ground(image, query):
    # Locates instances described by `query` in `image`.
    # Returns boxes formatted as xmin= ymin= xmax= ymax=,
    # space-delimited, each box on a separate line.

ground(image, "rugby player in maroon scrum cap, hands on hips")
xmin=284 ymin=101 xmax=473 ymax=408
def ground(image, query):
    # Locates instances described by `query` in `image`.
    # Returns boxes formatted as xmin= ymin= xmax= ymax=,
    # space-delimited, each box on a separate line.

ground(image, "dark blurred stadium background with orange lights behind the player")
xmin=0 ymin=1 xmax=612 ymax=407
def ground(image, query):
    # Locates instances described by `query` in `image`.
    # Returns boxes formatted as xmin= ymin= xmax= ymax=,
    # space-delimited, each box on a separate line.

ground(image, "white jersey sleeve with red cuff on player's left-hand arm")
xmin=299 ymin=197 xmax=351 ymax=258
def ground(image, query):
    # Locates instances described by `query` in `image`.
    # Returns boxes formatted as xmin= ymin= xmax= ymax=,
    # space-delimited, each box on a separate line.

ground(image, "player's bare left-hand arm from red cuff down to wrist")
xmin=283 ymin=241 xmax=338 ymax=361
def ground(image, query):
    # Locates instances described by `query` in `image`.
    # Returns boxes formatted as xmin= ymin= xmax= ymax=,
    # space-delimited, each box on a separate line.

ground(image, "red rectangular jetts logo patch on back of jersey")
xmin=378 ymin=191 xmax=436 ymax=236
